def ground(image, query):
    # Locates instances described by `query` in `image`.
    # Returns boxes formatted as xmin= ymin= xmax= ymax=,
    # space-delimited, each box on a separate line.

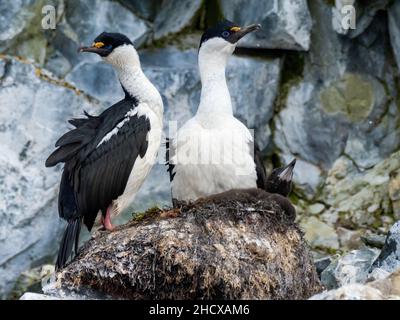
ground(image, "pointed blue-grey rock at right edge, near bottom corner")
xmin=372 ymin=221 xmax=400 ymax=272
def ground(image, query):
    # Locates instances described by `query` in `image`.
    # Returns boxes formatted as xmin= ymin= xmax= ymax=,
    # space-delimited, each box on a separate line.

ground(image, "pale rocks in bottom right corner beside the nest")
xmin=310 ymin=222 xmax=400 ymax=300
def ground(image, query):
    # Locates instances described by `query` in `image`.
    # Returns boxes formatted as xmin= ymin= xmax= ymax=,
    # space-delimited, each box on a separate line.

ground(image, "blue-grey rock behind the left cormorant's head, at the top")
xmin=45 ymin=0 xmax=150 ymax=79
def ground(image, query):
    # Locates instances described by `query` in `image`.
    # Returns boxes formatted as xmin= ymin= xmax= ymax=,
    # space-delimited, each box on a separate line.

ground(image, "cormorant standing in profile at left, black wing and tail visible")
xmin=46 ymin=32 xmax=163 ymax=269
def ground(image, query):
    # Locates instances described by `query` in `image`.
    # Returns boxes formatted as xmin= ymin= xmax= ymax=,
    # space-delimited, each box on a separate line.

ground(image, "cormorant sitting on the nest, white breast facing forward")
xmin=167 ymin=20 xmax=266 ymax=202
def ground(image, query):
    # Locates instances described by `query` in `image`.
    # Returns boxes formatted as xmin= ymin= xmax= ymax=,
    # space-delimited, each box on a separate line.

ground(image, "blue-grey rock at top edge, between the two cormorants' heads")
xmin=154 ymin=0 xmax=202 ymax=40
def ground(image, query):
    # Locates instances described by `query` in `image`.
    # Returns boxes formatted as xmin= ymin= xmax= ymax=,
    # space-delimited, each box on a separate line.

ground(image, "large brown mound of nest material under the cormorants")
xmin=57 ymin=189 xmax=321 ymax=299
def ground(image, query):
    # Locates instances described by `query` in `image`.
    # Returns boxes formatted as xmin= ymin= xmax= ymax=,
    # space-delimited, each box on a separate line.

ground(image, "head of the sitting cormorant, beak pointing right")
xmin=199 ymin=20 xmax=261 ymax=55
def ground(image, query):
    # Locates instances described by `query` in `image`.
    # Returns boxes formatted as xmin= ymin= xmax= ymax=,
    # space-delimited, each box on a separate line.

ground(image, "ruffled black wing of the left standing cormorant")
xmin=46 ymin=99 xmax=150 ymax=230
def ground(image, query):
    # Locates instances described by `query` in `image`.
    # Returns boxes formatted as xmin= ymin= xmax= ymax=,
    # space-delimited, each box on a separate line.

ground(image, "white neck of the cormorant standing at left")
xmin=117 ymin=62 xmax=163 ymax=117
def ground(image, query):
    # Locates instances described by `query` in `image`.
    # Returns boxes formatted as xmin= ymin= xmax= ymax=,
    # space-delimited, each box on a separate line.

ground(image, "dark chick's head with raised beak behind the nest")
xmin=265 ymin=159 xmax=296 ymax=197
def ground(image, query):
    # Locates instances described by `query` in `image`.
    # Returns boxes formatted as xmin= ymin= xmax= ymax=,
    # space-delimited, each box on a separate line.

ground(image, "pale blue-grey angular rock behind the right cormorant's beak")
xmin=220 ymin=0 xmax=312 ymax=51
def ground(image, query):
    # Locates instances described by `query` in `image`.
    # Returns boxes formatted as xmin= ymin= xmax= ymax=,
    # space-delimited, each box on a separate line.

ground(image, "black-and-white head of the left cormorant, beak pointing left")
xmin=79 ymin=32 xmax=140 ymax=68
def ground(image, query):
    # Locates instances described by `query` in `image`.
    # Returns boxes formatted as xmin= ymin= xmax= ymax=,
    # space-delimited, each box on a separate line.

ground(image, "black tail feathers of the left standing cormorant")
xmin=56 ymin=218 xmax=82 ymax=270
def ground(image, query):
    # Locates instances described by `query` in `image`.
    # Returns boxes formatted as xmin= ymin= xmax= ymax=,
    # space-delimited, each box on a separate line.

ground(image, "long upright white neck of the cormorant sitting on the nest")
xmin=197 ymin=50 xmax=233 ymax=115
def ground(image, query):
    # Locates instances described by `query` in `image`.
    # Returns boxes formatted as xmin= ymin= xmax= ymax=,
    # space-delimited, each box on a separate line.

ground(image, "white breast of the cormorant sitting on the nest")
xmin=171 ymin=114 xmax=257 ymax=201
